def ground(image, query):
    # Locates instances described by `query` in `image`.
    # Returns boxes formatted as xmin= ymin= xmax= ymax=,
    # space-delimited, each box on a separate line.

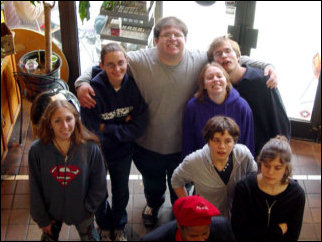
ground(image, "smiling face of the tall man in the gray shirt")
xmin=155 ymin=26 xmax=186 ymax=61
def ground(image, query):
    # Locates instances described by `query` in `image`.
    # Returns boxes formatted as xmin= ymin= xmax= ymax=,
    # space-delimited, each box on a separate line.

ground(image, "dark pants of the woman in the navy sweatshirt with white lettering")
xmin=95 ymin=156 xmax=132 ymax=230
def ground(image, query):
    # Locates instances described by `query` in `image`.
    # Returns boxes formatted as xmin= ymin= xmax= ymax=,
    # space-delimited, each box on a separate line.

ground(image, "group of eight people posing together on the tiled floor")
xmin=29 ymin=17 xmax=305 ymax=241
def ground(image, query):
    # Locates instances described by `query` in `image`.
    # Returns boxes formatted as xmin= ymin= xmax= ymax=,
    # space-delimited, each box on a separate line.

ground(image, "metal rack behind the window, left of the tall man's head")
xmin=100 ymin=1 xmax=156 ymax=46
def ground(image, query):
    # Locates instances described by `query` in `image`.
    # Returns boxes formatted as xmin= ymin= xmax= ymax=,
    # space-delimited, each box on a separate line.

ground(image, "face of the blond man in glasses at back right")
xmin=213 ymin=41 xmax=239 ymax=74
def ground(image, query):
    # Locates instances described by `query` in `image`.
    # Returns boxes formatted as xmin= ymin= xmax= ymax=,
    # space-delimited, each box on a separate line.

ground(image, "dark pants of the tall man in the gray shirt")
xmin=133 ymin=144 xmax=181 ymax=209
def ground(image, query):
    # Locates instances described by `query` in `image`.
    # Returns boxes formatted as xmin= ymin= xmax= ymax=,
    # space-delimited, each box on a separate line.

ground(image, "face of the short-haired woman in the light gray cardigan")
xmin=208 ymin=130 xmax=235 ymax=162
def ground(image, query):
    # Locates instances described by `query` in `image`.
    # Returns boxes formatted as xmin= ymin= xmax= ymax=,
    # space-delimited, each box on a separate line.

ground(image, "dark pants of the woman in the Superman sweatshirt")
xmin=41 ymin=214 xmax=100 ymax=241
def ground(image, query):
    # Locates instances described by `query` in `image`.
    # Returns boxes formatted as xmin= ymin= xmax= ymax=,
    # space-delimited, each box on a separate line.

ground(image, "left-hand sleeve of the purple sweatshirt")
xmin=182 ymin=102 xmax=198 ymax=159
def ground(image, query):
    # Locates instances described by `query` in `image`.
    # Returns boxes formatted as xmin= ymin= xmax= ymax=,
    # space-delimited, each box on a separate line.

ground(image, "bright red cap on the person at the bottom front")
xmin=172 ymin=194 xmax=220 ymax=227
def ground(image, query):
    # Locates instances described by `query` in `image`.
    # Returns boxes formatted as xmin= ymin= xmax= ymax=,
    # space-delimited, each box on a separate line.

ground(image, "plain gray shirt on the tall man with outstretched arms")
xmin=75 ymin=48 xmax=261 ymax=155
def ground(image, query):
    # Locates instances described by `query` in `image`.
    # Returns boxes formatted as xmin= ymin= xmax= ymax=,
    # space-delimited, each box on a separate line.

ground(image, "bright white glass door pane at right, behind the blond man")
xmin=251 ymin=1 xmax=321 ymax=121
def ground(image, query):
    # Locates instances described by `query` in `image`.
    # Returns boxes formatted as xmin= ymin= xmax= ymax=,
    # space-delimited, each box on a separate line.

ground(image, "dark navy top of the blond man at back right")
xmin=234 ymin=66 xmax=291 ymax=156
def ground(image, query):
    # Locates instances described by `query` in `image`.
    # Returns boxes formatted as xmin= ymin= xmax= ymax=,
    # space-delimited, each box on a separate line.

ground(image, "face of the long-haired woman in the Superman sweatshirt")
xmin=50 ymin=107 xmax=75 ymax=142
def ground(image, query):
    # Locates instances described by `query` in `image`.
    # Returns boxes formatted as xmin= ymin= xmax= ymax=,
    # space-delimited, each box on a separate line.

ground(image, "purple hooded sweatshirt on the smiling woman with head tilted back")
xmin=182 ymin=88 xmax=254 ymax=158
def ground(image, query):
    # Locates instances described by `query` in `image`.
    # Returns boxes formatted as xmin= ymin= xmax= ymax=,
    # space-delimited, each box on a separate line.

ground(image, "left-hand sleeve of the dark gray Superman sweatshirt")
xmin=28 ymin=146 xmax=51 ymax=228
